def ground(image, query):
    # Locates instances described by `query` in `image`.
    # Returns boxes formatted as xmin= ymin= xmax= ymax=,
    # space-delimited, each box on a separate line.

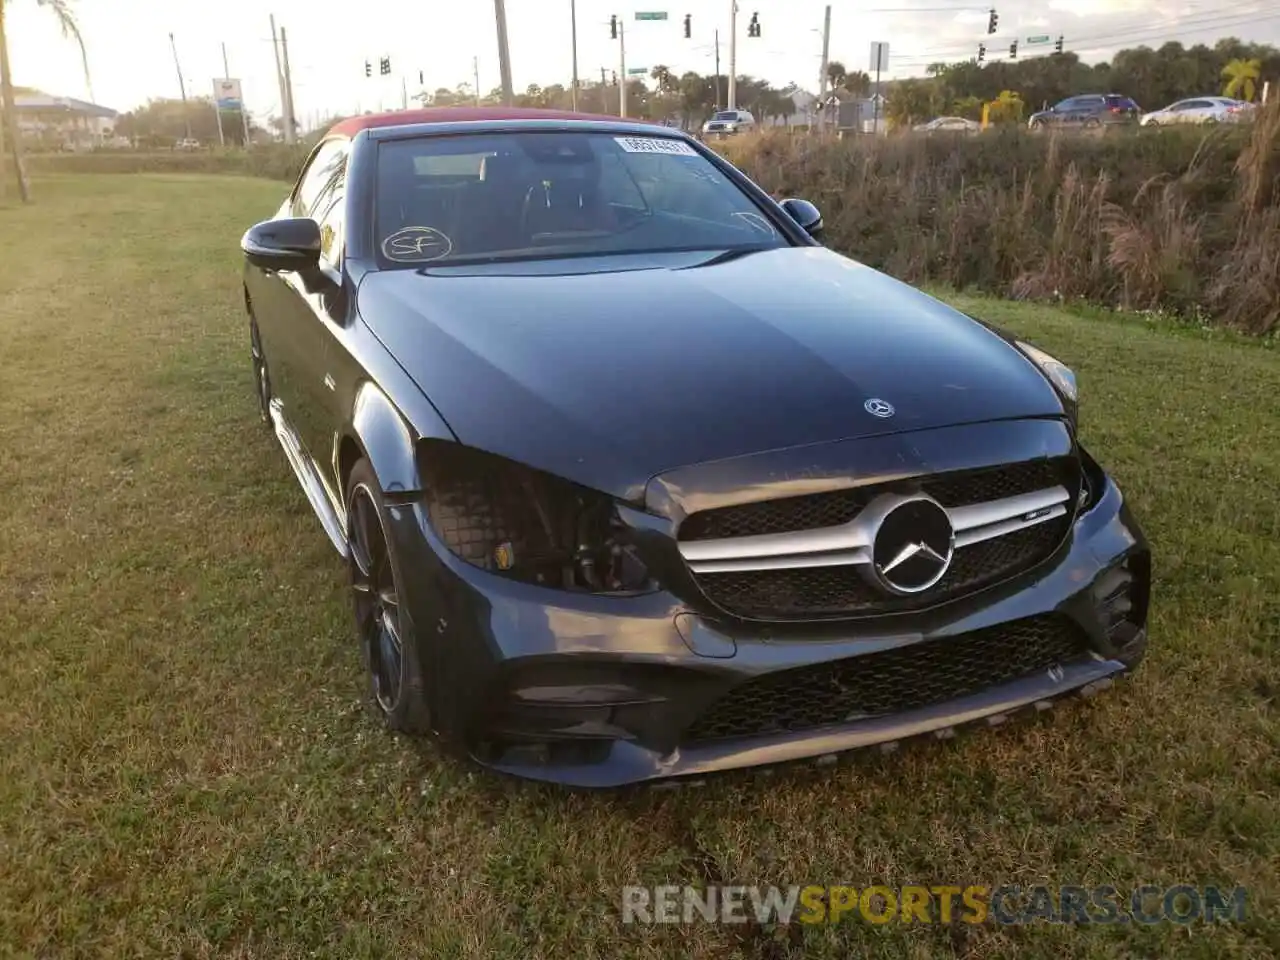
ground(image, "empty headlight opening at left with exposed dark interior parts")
xmin=419 ymin=440 xmax=653 ymax=594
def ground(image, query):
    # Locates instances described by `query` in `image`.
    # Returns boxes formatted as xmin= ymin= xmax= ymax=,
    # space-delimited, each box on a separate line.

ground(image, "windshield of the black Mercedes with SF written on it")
xmin=375 ymin=131 xmax=788 ymax=266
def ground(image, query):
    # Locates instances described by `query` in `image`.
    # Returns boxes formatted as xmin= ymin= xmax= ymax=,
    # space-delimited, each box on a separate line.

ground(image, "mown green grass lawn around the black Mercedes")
xmin=0 ymin=175 xmax=1280 ymax=960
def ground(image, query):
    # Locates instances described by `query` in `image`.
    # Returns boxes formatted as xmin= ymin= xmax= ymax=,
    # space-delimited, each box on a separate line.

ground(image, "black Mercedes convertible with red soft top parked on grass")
xmin=241 ymin=108 xmax=1151 ymax=786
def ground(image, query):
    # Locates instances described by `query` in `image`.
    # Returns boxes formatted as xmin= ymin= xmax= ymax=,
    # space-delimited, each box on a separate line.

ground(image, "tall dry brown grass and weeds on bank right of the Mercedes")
xmin=716 ymin=112 xmax=1280 ymax=334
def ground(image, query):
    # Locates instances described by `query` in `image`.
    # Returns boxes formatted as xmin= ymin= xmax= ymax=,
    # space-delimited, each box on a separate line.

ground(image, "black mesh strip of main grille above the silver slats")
xmin=680 ymin=457 xmax=1079 ymax=540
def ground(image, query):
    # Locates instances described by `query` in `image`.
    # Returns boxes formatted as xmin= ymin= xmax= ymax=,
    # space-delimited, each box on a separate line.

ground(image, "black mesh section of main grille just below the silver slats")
xmin=696 ymin=517 xmax=1069 ymax=620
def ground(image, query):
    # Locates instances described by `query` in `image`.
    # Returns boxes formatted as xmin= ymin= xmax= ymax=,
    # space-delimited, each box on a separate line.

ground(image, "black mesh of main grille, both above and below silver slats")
xmin=678 ymin=457 xmax=1079 ymax=621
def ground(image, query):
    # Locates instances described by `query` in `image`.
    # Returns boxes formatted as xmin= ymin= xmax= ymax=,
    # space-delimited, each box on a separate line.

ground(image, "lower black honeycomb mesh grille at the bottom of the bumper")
xmin=684 ymin=614 xmax=1088 ymax=742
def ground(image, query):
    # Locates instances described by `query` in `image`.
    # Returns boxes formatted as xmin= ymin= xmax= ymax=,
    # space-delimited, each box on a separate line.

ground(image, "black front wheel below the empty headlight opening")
xmin=346 ymin=460 xmax=431 ymax=735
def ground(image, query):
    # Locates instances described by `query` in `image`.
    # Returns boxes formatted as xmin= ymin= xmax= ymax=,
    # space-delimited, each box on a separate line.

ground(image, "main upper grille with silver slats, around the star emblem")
xmin=677 ymin=457 xmax=1080 ymax=621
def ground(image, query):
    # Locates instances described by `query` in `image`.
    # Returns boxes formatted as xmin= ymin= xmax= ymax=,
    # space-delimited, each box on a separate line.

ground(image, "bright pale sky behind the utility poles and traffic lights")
xmin=5 ymin=0 xmax=1280 ymax=125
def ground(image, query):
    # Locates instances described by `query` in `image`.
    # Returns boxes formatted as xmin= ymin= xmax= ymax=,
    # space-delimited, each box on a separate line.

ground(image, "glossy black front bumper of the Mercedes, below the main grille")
xmin=390 ymin=465 xmax=1151 ymax=787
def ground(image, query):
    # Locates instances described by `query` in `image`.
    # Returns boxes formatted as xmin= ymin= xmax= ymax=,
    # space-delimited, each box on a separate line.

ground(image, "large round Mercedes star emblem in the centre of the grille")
xmin=872 ymin=497 xmax=955 ymax=594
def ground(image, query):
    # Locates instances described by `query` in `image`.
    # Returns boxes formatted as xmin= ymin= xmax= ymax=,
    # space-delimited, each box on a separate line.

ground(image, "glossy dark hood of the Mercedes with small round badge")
xmin=358 ymin=247 xmax=1064 ymax=499
